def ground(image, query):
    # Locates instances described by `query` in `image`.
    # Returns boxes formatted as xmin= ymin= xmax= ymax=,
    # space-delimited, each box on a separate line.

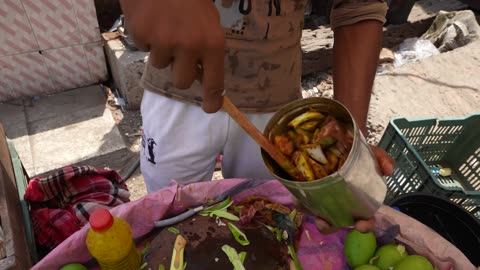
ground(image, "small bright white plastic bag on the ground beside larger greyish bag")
xmin=393 ymin=38 xmax=440 ymax=67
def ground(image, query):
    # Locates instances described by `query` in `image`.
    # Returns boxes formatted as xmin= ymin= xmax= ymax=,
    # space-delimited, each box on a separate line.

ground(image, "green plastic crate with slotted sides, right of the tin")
xmin=379 ymin=114 xmax=480 ymax=219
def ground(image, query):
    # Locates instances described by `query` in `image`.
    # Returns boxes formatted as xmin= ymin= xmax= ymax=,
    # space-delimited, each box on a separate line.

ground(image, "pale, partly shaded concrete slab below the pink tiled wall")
xmin=0 ymin=85 xmax=129 ymax=176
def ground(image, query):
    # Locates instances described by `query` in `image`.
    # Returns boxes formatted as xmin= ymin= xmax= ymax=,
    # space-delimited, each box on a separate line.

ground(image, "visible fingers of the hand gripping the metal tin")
xmin=315 ymin=145 xmax=395 ymax=233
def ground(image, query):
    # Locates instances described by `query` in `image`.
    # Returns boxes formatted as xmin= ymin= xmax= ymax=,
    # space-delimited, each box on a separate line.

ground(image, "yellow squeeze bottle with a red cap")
xmin=86 ymin=208 xmax=142 ymax=270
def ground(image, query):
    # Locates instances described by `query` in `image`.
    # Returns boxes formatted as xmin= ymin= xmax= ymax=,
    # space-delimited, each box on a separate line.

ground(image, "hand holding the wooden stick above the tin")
xmin=120 ymin=0 xmax=225 ymax=113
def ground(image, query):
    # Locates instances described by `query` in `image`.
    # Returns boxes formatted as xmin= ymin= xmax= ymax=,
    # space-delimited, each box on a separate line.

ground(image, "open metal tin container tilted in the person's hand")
xmin=262 ymin=97 xmax=387 ymax=227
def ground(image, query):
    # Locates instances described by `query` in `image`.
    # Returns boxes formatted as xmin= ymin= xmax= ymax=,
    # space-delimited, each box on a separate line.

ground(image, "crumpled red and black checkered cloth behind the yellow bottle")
xmin=25 ymin=166 xmax=130 ymax=249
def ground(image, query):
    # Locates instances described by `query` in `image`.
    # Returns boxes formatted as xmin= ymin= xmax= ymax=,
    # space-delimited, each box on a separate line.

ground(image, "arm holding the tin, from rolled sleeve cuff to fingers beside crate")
xmin=331 ymin=0 xmax=395 ymax=175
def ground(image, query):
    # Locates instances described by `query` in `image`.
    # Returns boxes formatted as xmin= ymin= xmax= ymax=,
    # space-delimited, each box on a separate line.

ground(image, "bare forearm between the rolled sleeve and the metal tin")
xmin=333 ymin=20 xmax=382 ymax=135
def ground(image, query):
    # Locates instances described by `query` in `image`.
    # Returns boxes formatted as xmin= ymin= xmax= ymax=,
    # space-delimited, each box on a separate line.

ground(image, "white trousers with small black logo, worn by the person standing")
xmin=140 ymin=90 xmax=273 ymax=192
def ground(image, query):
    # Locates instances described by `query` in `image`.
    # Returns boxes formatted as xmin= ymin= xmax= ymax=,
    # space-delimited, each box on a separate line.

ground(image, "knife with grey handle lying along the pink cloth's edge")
xmin=154 ymin=179 xmax=268 ymax=228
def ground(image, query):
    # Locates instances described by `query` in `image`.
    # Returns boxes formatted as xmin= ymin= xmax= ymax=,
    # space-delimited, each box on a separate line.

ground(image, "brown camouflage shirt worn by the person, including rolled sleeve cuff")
xmin=141 ymin=0 xmax=387 ymax=112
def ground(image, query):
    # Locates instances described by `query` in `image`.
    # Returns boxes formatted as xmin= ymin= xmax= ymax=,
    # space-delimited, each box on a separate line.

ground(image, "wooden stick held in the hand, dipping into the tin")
xmin=223 ymin=96 xmax=304 ymax=181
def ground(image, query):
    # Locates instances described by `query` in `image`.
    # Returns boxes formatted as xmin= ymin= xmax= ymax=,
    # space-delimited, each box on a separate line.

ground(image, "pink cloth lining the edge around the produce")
xmin=32 ymin=179 xmax=476 ymax=270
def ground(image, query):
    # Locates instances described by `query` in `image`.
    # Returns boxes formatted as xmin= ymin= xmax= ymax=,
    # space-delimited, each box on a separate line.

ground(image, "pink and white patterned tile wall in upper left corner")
xmin=0 ymin=0 xmax=108 ymax=102
